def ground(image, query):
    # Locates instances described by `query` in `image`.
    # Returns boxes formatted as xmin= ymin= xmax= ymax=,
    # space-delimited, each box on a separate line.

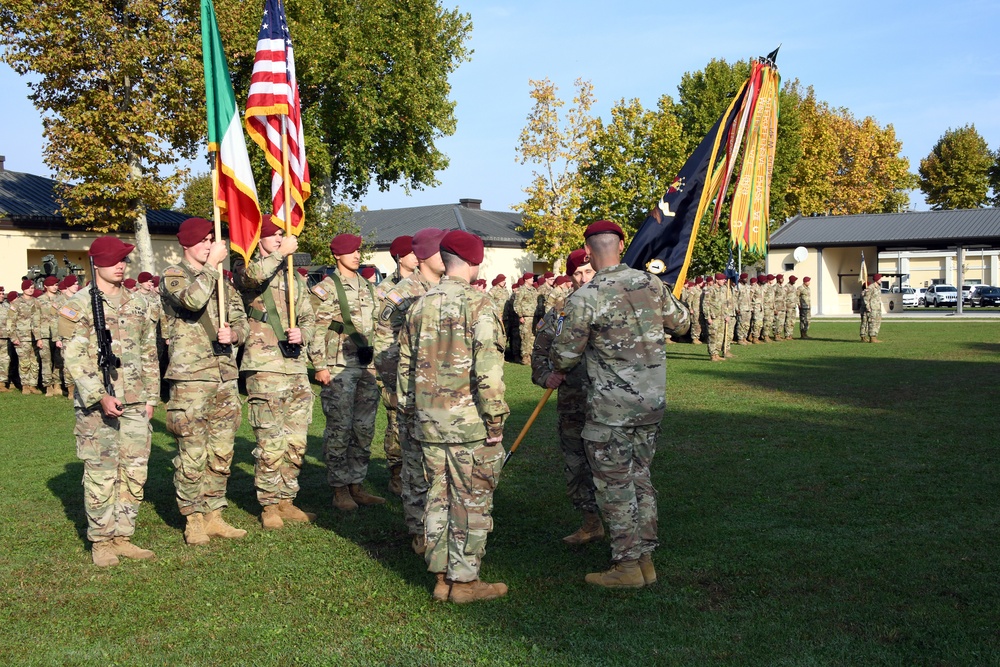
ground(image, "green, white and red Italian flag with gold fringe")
xmin=201 ymin=0 xmax=261 ymax=262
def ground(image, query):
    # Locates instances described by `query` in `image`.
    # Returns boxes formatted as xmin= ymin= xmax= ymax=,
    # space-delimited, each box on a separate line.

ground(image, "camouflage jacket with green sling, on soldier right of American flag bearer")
xmin=309 ymin=273 xmax=375 ymax=370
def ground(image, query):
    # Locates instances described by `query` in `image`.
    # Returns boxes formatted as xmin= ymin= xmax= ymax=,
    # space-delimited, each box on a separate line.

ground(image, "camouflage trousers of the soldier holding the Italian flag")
xmin=166 ymin=380 xmax=243 ymax=516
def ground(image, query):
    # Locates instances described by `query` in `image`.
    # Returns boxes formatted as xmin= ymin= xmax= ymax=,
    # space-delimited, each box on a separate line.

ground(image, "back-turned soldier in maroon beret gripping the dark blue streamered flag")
xmin=550 ymin=220 xmax=690 ymax=588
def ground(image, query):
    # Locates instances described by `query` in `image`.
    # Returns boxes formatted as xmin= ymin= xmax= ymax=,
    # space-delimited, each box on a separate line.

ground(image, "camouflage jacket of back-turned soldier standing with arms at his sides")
xmin=396 ymin=276 xmax=510 ymax=443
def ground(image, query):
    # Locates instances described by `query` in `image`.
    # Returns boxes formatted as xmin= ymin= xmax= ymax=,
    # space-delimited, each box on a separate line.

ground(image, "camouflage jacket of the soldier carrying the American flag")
xmin=233 ymin=252 xmax=316 ymax=375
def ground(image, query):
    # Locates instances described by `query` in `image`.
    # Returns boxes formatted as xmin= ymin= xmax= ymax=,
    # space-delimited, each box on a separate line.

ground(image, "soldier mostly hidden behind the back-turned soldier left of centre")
xmin=375 ymin=228 xmax=446 ymax=554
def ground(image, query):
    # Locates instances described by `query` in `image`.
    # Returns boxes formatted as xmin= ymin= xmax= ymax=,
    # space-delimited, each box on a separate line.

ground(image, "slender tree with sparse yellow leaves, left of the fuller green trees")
xmin=514 ymin=79 xmax=596 ymax=264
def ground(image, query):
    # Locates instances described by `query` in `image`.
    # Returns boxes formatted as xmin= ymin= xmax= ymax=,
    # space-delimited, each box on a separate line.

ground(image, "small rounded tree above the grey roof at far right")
xmin=920 ymin=125 xmax=996 ymax=209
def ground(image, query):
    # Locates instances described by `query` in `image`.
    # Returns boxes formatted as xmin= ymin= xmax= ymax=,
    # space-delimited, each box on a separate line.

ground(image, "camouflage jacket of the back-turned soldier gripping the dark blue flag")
xmin=552 ymin=264 xmax=690 ymax=427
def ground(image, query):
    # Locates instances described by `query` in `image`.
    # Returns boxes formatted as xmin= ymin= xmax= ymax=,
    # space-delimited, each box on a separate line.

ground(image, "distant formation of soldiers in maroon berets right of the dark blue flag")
xmin=681 ymin=273 xmax=812 ymax=361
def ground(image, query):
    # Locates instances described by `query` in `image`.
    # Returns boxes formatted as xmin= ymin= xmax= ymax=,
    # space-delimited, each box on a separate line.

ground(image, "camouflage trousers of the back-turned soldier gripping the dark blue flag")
xmin=583 ymin=421 xmax=660 ymax=562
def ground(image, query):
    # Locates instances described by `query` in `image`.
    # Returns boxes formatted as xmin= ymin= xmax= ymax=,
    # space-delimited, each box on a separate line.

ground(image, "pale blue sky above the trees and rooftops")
xmin=0 ymin=0 xmax=1000 ymax=210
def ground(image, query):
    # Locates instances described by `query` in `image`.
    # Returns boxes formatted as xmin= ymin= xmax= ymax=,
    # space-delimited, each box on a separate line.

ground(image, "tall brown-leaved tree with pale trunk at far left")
xmin=0 ymin=0 xmax=204 ymax=270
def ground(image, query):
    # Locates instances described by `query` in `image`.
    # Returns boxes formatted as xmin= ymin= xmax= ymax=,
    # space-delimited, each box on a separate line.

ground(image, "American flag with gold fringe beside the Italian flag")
xmin=245 ymin=0 xmax=310 ymax=236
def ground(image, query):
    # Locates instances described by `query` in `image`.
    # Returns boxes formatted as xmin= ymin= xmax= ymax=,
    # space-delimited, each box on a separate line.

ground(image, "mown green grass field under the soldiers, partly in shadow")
xmin=0 ymin=321 xmax=1000 ymax=667
